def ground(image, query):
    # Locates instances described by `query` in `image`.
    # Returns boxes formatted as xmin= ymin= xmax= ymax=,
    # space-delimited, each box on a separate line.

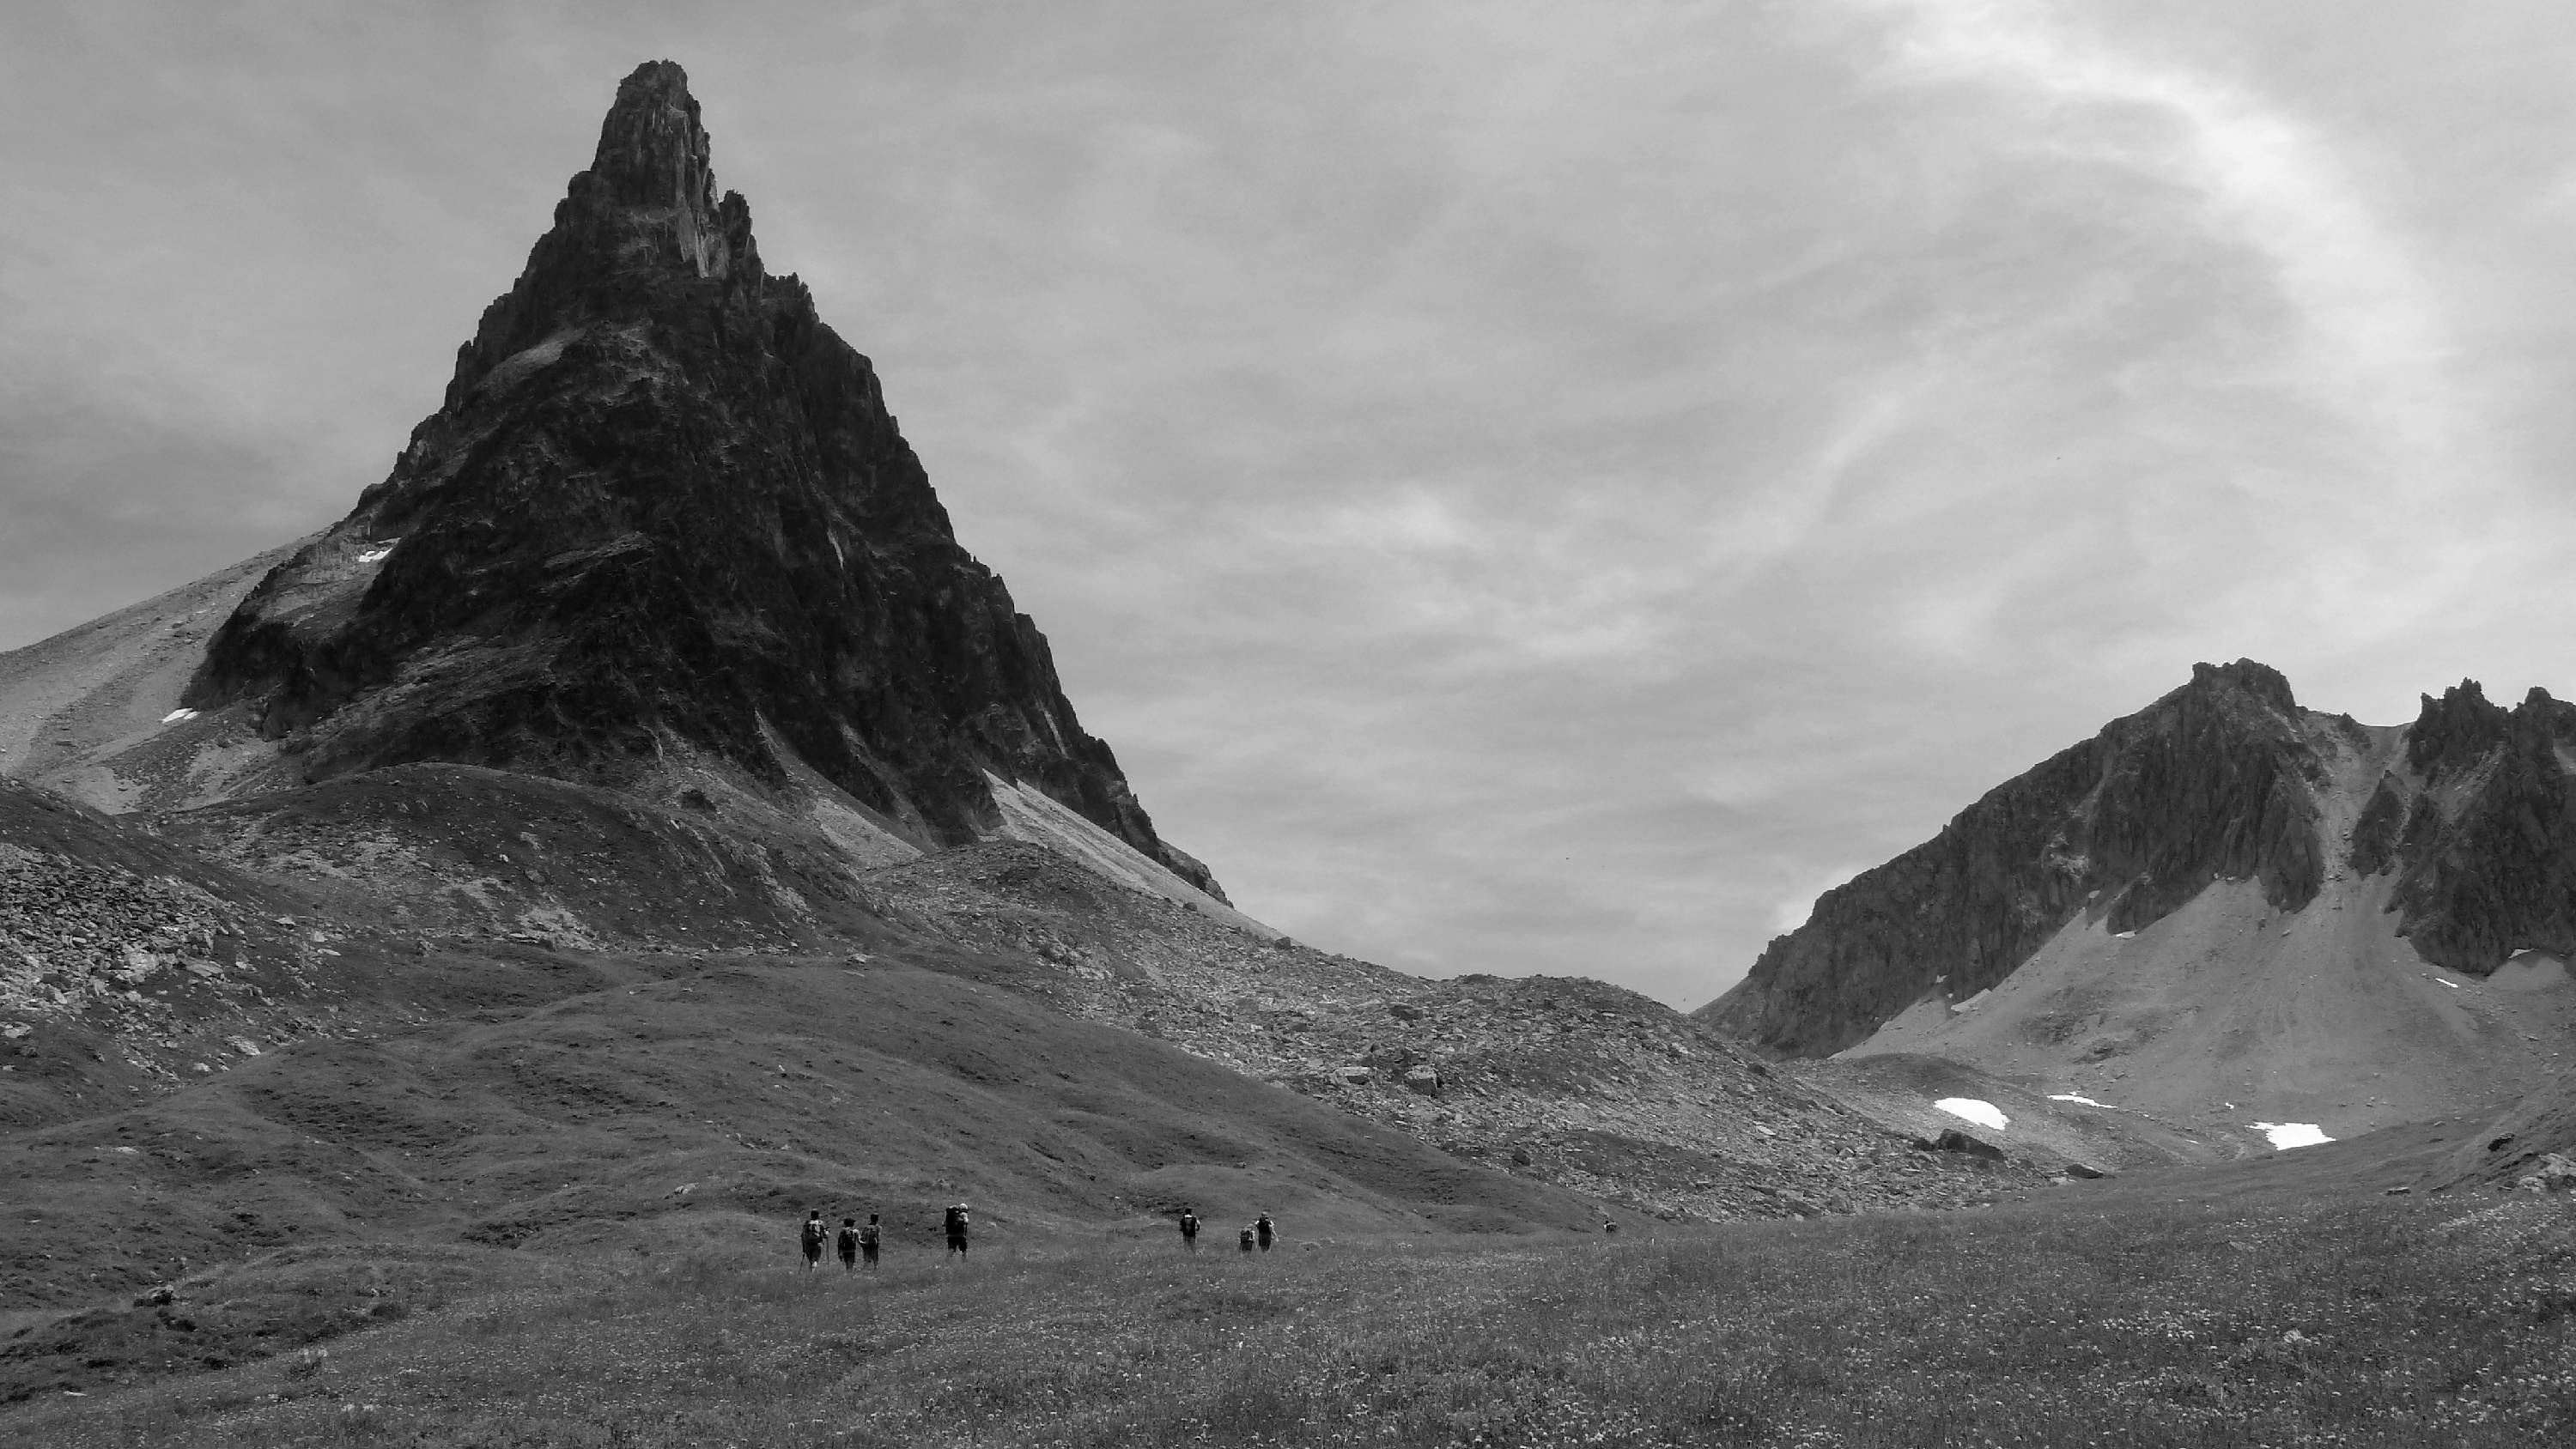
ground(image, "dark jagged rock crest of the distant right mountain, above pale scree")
xmin=1700 ymin=659 xmax=2576 ymax=1055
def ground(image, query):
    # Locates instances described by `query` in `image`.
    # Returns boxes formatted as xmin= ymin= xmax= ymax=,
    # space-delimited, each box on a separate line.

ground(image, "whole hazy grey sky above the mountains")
xmin=0 ymin=0 xmax=2576 ymax=1006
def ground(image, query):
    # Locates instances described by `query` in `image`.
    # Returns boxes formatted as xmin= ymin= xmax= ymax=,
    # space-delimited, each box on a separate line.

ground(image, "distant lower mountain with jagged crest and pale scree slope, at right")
xmin=1703 ymin=662 xmax=2576 ymax=1137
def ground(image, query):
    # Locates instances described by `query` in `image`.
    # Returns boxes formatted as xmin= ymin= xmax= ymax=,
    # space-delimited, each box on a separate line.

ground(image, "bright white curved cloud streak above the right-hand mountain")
xmin=1886 ymin=0 xmax=2501 ymax=634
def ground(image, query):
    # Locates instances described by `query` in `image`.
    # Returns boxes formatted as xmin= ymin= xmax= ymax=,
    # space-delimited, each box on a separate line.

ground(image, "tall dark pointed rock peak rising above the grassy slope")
xmin=191 ymin=62 xmax=1216 ymax=890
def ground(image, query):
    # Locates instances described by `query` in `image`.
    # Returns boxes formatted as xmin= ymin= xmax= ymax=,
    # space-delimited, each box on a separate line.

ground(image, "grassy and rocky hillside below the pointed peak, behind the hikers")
xmin=0 ymin=764 xmax=2040 ymax=1400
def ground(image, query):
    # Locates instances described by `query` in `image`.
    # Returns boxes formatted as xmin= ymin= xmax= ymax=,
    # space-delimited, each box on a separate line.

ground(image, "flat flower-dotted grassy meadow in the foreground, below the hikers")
xmin=20 ymin=1199 xmax=2576 ymax=1449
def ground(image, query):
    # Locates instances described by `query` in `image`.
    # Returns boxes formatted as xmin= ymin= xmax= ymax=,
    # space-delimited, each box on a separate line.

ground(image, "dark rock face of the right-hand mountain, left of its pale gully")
xmin=1700 ymin=659 xmax=2357 ymax=1055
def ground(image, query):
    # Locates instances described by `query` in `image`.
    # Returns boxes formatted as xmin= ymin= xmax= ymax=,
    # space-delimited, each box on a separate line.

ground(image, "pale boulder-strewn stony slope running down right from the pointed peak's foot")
xmin=866 ymin=841 xmax=2061 ymax=1220
